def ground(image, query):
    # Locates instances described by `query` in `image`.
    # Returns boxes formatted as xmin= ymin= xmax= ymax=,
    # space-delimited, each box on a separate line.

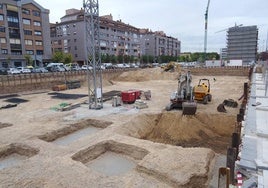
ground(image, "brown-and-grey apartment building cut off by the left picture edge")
xmin=0 ymin=0 xmax=52 ymax=68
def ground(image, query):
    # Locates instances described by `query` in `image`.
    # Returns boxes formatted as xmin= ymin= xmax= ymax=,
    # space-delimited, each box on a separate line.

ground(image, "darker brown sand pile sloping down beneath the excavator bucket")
xmin=144 ymin=112 xmax=235 ymax=153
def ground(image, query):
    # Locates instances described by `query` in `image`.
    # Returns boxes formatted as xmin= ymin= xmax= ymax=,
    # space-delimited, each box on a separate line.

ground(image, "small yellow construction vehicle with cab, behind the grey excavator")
xmin=193 ymin=78 xmax=212 ymax=104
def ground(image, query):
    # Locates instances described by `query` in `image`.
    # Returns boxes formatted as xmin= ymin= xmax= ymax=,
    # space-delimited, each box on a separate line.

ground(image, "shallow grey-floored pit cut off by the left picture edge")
xmin=0 ymin=144 xmax=39 ymax=170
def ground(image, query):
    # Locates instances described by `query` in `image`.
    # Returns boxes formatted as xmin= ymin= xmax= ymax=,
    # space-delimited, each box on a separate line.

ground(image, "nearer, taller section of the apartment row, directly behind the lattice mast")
xmin=50 ymin=9 xmax=141 ymax=64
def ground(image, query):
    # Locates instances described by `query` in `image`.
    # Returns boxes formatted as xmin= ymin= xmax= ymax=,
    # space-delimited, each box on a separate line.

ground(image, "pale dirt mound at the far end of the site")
xmin=115 ymin=67 xmax=179 ymax=82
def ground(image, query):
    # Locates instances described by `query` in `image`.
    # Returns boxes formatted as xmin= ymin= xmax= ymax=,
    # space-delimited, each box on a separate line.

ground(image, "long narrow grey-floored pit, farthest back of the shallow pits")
xmin=39 ymin=119 xmax=112 ymax=146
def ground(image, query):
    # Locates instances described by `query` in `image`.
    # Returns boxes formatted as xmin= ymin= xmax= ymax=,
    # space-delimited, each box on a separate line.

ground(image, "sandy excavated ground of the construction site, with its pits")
xmin=0 ymin=63 xmax=258 ymax=187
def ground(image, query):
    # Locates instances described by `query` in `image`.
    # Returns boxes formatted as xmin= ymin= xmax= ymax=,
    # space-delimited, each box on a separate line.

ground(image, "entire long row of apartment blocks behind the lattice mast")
xmin=50 ymin=9 xmax=180 ymax=64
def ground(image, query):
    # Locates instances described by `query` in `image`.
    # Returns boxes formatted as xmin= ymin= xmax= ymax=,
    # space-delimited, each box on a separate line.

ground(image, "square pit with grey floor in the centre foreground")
xmin=72 ymin=141 xmax=148 ymax=176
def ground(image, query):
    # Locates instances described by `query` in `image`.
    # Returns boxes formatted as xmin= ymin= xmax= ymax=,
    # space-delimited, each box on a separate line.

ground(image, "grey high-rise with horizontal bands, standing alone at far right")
xmin=227 ymin=26 xmax=258 ymax=65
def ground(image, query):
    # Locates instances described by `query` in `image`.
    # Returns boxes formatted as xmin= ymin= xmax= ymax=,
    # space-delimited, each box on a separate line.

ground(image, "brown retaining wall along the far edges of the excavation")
xmin=0 ymin=67 xmax=250 ymax=95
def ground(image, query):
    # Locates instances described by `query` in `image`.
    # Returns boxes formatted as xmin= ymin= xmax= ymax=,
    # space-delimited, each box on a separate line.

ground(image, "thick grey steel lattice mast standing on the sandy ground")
xmin=83 ymin=0 xmax=103 ymax=109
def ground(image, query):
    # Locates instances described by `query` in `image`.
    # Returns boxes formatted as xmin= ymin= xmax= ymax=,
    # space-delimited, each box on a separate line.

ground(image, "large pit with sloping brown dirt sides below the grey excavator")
xmin=119 ymin=111 xmax=236 ymax=154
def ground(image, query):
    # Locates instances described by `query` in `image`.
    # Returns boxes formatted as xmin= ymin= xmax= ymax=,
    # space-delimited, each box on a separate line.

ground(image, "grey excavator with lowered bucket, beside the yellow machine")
xmin=166 ymin=71 xmax=197 ymax=115
